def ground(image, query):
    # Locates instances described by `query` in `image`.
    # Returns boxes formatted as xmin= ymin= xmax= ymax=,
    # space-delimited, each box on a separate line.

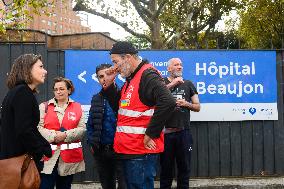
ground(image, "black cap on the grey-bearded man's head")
xmin=109 ymin=41 xmax=138 ymax=54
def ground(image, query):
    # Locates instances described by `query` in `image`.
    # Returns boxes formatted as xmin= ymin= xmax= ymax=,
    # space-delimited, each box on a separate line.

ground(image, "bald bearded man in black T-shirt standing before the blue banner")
xmin=160 ymin=58 xmax=200 ymax=189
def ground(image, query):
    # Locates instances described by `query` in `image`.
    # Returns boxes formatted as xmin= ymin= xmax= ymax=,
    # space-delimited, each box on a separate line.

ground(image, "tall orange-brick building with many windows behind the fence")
xmin=0 ymin=0 xmax=91 ymax=35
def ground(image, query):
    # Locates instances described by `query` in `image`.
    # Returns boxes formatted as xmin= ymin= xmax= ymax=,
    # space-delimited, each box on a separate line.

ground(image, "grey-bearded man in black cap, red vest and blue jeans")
xmin=104 ymin=41 xmax=175 ymax=189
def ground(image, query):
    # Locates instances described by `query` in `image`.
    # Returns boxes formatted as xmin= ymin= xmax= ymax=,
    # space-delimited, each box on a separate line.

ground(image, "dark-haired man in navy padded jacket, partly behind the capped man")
xmin=87 ymin=64 xmax=126 ymax=189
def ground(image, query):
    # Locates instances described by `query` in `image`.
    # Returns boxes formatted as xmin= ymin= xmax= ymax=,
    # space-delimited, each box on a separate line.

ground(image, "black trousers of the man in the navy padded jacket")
xmin=94 ymin=146 xmax=126 ymax=189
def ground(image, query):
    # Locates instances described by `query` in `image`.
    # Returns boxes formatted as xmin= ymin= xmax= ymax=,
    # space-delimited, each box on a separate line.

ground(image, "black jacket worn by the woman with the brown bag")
xmin=0 ymin=83 xmax=52 ymax=162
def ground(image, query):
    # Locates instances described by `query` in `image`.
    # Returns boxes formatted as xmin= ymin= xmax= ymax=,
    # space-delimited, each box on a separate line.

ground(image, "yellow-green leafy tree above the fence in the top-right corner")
xmin=239 ymin=0 xmax=284 ymax=49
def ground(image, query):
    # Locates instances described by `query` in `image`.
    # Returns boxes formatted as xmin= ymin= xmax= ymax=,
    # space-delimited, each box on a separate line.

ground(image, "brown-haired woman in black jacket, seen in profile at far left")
xmin=0 ymin=54 xmax=52 ymax=169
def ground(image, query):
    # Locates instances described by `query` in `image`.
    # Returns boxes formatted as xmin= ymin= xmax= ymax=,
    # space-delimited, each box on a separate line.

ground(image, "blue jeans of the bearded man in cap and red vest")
xmin=122 ymin=154 xmax=158 ymax=189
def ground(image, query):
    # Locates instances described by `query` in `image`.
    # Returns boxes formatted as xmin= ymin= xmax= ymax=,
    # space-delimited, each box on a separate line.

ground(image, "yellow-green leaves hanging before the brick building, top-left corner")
xmin=0 ymin=0 xmax=51 ymax=33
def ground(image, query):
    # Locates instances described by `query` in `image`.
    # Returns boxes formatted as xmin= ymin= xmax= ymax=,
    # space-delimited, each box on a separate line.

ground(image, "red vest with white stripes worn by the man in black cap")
xmin=114 ymin=64 xmax=164 ymax=154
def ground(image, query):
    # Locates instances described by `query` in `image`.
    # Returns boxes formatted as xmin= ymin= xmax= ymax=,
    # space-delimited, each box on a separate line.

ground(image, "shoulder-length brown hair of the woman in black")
xmin=7 ymin=54 xmax=41 ymax=91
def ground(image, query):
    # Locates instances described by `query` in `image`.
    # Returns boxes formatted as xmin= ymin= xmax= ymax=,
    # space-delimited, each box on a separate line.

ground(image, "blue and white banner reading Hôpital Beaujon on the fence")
xmin=65 ymin=50 xmax=278 ymax=121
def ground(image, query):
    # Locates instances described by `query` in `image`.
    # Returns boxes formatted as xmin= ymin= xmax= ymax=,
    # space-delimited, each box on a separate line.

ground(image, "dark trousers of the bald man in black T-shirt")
xmin=160 ymin=129 xmax=192 ymax=189
